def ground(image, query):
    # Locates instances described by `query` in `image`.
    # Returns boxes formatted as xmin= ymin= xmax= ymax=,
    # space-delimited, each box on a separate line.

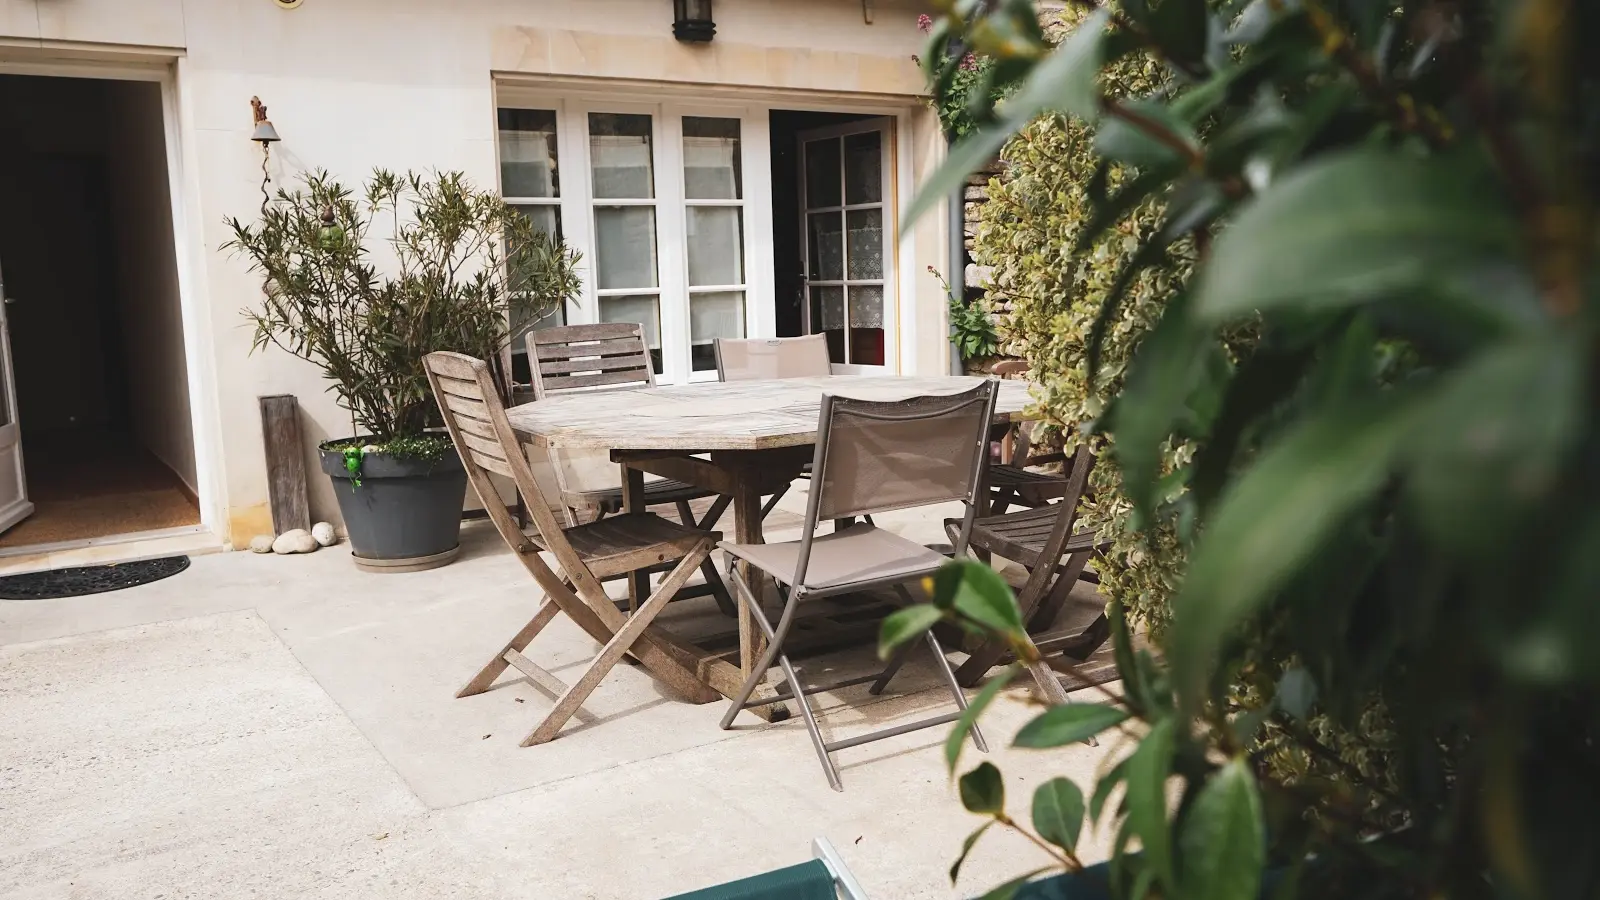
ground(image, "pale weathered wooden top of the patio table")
xmin=507 ymin=375 xmax=1029 ymax=450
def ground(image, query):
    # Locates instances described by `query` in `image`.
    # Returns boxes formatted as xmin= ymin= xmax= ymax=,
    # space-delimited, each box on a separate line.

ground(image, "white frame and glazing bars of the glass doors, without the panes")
xmin=493 ymin=87 xmax=915 ymax=384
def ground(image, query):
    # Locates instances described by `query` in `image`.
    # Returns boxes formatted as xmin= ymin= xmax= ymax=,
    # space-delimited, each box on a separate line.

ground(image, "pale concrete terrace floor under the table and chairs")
xmin=0 ymin=488 xmax=1117 ymax=900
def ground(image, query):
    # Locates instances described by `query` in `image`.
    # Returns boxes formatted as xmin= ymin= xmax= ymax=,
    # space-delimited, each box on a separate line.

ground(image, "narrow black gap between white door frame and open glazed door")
xmin=768 ymin=109 xmax=875 ymax=338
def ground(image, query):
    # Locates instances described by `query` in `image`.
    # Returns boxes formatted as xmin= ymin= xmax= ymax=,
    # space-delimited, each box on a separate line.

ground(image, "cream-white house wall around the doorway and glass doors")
xmin=0 ymin=0 xmax=947 ymax=543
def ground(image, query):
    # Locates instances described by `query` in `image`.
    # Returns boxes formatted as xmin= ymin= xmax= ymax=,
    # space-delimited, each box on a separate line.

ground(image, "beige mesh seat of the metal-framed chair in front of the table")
xmin=717 ymin=524 xmax=946 ymax=589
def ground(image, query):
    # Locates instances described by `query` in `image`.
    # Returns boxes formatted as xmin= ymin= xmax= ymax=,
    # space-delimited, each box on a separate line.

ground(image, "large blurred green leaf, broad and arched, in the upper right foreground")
xmin=1195 ymin=149 xmax=1522 ymax=322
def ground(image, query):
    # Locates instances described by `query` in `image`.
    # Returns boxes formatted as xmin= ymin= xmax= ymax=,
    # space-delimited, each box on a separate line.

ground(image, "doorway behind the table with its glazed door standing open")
xmin=770 ymin=109 xmax=894 ymax=373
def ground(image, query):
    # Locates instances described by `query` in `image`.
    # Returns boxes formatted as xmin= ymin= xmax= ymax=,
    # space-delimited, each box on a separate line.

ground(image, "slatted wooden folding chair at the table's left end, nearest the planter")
xmin=426 ymin=352 xmax=720 ymax=746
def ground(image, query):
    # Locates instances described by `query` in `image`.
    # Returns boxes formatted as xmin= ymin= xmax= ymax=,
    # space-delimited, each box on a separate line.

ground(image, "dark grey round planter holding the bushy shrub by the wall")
xmin=318 ymin=445 xmax=467 ymax=572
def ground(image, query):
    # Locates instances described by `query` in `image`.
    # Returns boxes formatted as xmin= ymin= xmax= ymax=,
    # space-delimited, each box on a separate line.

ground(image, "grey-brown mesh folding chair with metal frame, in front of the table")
xmin=718 ymin=380 xmax=998 ymax=791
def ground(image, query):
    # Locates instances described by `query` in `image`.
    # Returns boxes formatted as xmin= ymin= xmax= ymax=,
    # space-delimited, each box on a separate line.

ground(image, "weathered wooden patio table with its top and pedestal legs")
xmin=507 ymin=375 xmax=1029 ymax=721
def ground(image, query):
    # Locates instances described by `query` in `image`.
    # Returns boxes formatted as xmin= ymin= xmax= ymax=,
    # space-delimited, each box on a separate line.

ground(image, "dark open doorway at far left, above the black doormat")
xmin=0 ymin=75 xmax=200 ymax=552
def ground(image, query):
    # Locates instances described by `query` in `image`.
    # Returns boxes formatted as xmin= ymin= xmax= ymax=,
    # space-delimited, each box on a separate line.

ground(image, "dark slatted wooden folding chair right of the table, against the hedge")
xmin=944 ymin=445 xmax=1110 ymax=703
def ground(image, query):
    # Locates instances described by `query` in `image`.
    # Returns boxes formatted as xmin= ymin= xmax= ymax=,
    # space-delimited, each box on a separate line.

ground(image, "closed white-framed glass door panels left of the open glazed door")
xmin=498 ymin=90 xmax=773 ymax=383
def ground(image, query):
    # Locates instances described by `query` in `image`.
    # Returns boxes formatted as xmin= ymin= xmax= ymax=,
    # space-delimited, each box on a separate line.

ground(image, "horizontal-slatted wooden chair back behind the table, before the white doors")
xmin=526 ymin=322 xmax=656 ymax=399
